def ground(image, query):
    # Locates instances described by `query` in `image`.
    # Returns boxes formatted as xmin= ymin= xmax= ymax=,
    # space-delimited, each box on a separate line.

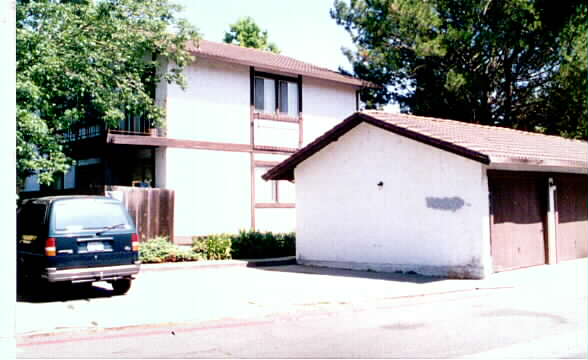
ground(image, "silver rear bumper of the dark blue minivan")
xmin=42 ymin=264 xmax=140 ymax=282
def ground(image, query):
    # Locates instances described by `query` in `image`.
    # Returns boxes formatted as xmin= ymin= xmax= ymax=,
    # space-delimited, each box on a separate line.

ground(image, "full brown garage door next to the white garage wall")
xmin=488 ymin=172 xmax=547 ymax=271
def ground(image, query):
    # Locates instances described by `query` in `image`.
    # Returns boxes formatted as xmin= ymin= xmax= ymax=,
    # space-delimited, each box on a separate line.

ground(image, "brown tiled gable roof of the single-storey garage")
xmin=263 ymin=111 xmax=588 ymax=180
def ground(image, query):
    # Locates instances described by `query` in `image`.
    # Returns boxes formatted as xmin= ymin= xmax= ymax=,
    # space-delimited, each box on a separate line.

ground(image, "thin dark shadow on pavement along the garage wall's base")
xmin=257 ymin=265 xmax=447 ymax=284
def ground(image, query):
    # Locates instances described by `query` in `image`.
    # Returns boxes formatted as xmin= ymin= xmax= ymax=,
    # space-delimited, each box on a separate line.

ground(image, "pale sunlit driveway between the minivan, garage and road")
xmin=16 ymin=259 xmax=588 ymax=335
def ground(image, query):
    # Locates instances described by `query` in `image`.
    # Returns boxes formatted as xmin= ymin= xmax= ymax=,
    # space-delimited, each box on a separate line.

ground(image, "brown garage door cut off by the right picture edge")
xmin=555 ymin=175 xmax=588 ymax=262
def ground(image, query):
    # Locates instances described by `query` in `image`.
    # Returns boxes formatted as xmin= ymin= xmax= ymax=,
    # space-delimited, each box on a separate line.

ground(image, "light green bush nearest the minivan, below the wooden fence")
xmin=139 ymin=236 xmax=202 ymax=264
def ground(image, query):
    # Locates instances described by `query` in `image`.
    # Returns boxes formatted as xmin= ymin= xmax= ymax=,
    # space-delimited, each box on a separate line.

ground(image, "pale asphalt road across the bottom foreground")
xmin=17 ymin=279 xmax=588 ymax=359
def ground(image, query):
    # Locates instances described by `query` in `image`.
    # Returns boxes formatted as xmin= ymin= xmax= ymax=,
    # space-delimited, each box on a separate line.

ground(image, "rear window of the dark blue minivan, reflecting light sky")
xmin=51 ymin=199 xmax=131 ymax=232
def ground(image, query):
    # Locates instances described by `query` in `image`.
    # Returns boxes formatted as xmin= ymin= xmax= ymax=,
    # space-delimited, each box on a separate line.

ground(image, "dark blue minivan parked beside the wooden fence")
xmin=17 ymin=196 xmax=140 ymax=294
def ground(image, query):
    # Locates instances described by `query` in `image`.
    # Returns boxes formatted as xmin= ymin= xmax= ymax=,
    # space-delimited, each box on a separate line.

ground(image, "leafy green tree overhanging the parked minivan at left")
xmin=16 ymin=0 xmax=198 ymax=184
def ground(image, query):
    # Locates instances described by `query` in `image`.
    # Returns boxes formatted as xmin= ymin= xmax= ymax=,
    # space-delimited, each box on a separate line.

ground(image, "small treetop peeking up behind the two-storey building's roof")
xmin=224 ymin=16 xmax=280 ymax=54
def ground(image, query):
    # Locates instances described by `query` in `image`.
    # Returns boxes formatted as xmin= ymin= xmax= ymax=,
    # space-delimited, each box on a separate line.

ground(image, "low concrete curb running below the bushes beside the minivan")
xmin=141 ymin=256 xmax=296 ymax=271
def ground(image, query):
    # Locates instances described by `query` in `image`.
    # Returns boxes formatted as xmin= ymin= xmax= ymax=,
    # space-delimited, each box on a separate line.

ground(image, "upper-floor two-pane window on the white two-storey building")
xmin=255 ymin=77 xmax=299 ymax=117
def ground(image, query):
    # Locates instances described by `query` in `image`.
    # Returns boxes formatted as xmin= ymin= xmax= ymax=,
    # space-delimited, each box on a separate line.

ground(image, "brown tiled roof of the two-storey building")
xmin=188 ymin=40 xmax=370 ymax=86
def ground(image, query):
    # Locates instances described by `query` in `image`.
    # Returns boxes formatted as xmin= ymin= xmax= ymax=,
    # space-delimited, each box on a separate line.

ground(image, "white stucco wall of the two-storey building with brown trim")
xmin=156 ymin=58 xmax=355 ymax=239
